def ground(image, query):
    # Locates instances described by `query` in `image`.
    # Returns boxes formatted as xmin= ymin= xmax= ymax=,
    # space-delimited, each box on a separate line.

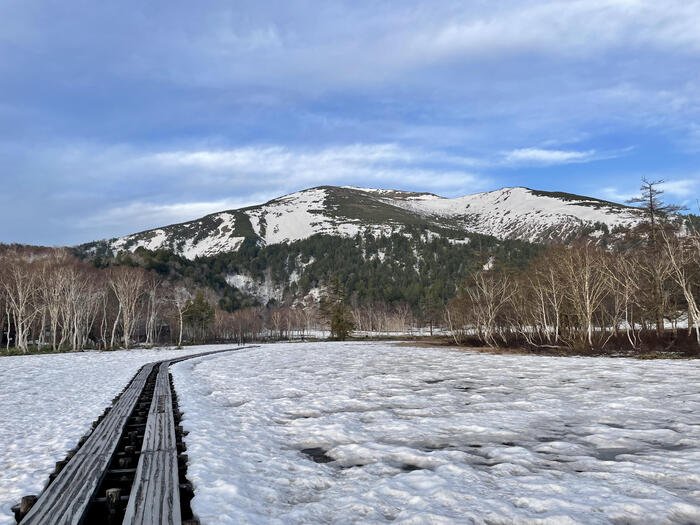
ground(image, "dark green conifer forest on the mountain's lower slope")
xmin=79 ymin=230 xmax=541 ymax=313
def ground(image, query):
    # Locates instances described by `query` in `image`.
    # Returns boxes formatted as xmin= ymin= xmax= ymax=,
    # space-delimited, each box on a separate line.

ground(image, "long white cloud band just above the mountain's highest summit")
xmin=140 ymin=144 xmax=488 ymax=191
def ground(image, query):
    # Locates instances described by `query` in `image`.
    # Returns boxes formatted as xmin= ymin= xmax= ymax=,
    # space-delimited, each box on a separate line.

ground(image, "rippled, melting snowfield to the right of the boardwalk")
xmin=173 ymin=343 xmax=700 ymax=525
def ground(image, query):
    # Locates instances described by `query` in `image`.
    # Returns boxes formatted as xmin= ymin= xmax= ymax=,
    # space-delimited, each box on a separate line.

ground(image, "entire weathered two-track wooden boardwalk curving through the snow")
xmin=15 ymin=347 xmax=251 ymax=525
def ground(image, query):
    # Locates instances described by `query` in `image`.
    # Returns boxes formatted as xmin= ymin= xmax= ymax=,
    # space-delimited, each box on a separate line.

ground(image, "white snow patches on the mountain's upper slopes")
xmin=102 ymin=186 xmax=640 ymax=259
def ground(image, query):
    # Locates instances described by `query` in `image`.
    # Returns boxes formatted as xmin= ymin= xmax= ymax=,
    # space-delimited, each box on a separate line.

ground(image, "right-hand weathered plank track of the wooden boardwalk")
xmin=122 ymin=361 xmax=181 ymax=525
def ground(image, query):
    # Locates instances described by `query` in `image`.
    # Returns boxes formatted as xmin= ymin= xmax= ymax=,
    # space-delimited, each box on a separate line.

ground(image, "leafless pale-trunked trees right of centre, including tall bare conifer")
xmin=444 ymin=180 xmax=700 ymax=353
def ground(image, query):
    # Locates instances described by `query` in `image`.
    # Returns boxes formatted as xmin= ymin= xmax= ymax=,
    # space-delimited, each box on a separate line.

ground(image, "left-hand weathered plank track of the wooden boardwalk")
xmin=22 ymin=364 xmax=153 ymax=525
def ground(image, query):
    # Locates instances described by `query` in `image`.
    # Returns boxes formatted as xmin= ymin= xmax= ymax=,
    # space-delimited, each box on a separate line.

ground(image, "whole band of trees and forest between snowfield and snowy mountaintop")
xmin=0 ymin=181 xmax=700 ymax=352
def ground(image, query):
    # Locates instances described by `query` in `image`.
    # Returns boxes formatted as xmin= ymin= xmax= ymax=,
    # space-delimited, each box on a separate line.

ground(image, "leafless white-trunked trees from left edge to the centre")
xmin=0 ymin=246 xmax=442 ymax=353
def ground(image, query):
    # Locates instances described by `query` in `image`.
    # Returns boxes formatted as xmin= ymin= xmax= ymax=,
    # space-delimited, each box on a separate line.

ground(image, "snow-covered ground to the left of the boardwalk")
xmin=0 ymin=345 xmax=237 ymax=525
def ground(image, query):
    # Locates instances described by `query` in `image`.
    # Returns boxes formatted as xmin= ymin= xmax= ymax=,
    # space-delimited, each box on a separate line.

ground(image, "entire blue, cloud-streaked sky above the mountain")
xmin=0 ymin=0 xmax=700 ymax=245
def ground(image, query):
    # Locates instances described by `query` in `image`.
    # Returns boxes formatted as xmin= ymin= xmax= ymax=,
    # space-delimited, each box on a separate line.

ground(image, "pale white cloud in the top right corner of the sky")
xmin=409 ymin=0 xmax=700 ymax=64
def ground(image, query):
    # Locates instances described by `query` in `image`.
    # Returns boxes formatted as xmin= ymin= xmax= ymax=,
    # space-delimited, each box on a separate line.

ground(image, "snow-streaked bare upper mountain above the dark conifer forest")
xmin=82 ymin=186 xmax=640 ymax=259
